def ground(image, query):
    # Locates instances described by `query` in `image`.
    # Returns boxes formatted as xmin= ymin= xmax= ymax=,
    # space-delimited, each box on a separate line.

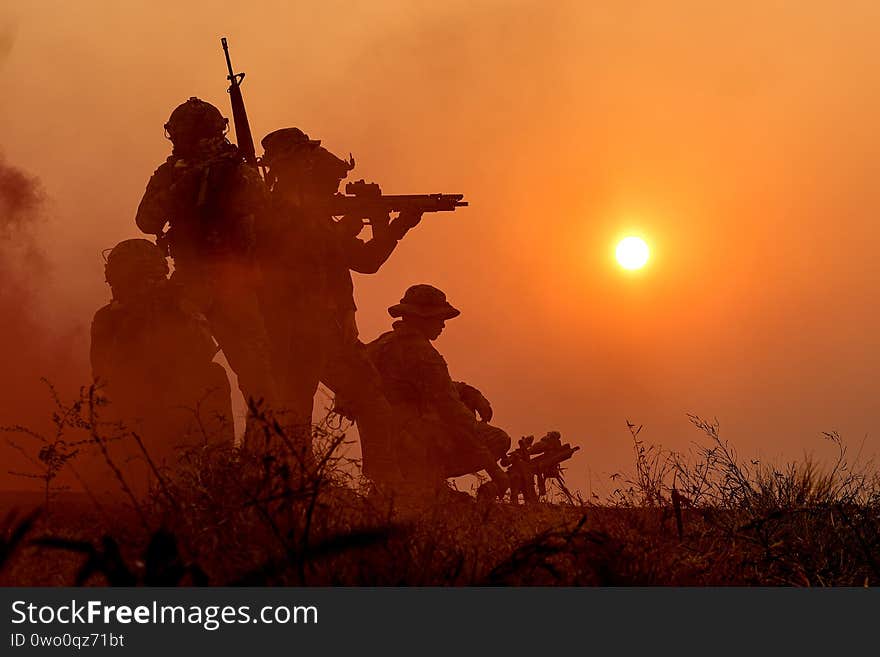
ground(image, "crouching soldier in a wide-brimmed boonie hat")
xmin=367 ymin=285 xmax=510 ymax=496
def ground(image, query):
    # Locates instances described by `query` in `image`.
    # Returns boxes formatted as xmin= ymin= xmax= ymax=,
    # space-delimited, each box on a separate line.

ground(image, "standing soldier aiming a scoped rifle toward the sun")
xmin=261 ymin=128 xmax=421 ymax=488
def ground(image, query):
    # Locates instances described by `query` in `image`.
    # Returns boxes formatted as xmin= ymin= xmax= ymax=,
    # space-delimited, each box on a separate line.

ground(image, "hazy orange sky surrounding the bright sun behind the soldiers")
xmin=0 ymin=0 xmax=880 ymax=488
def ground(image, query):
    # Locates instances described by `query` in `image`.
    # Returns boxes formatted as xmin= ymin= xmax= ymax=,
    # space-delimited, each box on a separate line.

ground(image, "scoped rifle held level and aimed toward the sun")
xmin=324 ymin=180 xmax=467 ymax=223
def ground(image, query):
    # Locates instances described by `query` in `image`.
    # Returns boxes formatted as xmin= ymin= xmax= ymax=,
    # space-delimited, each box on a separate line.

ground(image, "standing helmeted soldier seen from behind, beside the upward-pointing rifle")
xmin=136 ymin=98 xmax=276 ymax=428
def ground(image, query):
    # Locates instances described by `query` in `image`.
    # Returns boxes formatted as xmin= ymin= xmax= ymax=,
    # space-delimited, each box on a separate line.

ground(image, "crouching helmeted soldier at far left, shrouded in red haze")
xmin=91 ymin=239 xmax=234 ymax=490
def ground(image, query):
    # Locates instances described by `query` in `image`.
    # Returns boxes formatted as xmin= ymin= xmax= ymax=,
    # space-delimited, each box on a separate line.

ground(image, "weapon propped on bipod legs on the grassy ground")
xmin=501 ymin=431 xmax=580 ymax=503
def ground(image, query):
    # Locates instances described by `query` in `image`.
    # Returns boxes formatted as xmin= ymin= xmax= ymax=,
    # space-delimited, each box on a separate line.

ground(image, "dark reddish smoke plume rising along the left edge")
xmin=0 ymin=156 xmax=87 ymax=486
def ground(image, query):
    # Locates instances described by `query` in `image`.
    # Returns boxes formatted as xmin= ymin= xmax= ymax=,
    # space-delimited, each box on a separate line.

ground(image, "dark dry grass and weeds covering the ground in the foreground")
xmin=0 ymin=389 xmax=880 ymax=586
